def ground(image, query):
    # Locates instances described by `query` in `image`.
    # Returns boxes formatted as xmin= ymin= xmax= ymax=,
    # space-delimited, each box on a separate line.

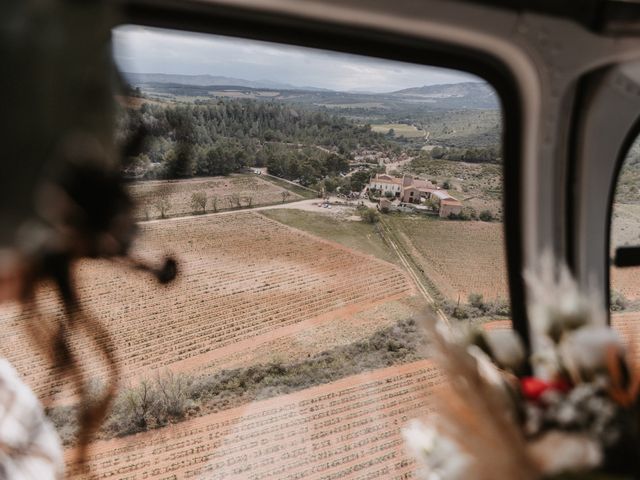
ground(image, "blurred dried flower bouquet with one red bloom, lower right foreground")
xmin=403 ymin=256 xmax=640 ymax=480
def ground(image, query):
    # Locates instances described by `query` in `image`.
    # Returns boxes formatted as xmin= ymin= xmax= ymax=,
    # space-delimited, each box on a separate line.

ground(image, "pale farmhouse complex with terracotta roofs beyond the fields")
xmin=369 ymin=173 xmax=462 ymax=217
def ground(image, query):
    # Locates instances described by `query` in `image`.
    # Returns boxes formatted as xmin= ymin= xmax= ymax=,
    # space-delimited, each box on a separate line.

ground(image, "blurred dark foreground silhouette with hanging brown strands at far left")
xmin=0 ymin=0 xmax=177 ymax=463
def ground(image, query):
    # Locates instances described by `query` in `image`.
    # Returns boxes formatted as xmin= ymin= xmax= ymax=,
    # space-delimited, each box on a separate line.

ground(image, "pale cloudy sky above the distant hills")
xmin=113 ymin=26 xmax=479 ymax=92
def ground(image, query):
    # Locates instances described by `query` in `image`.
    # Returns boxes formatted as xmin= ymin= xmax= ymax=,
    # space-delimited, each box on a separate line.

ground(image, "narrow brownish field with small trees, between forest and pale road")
xmin=130 ymin=174 xmax=303 ymax=220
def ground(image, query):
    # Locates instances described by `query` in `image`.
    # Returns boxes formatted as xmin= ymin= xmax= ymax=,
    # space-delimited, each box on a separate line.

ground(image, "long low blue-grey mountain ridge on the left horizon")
xmin=123 ymin=72 xmax=331 ymax=92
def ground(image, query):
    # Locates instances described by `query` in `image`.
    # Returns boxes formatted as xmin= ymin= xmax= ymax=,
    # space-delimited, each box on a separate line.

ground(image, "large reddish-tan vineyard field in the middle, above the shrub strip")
xmin=0 ymin=212 xmax=413 ymax=404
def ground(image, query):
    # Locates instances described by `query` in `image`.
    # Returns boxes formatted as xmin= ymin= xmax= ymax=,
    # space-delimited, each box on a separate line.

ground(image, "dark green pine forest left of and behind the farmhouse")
xmin=118 ymin=99 xmax=391 ymax=185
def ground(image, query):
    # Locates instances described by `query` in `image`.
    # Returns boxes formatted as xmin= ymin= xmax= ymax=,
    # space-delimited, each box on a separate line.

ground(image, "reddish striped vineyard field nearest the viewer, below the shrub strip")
xmin=66 ymin=360 xmax=443 ymax=480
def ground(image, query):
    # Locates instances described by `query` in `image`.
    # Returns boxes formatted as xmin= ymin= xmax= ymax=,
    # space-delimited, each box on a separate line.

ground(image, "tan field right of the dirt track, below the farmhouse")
xmin=385 ymin=215 xmax=508 ymax=302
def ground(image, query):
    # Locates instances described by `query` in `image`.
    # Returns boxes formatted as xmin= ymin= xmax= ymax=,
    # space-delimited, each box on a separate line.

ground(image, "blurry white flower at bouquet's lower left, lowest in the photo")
xmin=402 ymin=420 xmax=473 ymax=480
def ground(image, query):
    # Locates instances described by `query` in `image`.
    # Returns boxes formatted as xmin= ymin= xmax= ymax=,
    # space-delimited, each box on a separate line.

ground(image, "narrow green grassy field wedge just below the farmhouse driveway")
xmin=260 ymin=208 xmax=398 ymax=263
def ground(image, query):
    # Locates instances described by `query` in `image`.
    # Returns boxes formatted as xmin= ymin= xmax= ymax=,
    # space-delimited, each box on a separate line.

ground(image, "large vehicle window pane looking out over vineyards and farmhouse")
xmin=0 ymin=26 xmax=510 ymax=479
